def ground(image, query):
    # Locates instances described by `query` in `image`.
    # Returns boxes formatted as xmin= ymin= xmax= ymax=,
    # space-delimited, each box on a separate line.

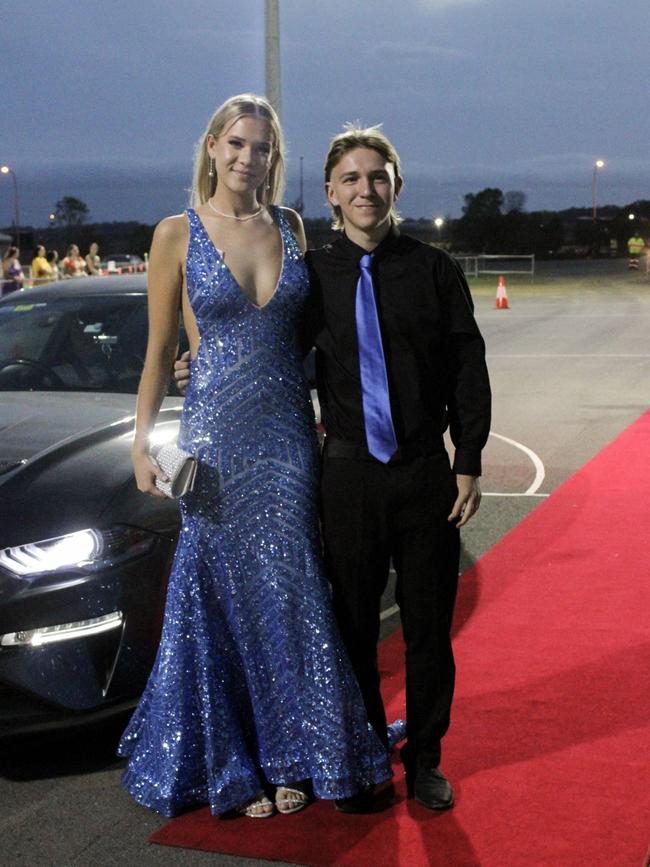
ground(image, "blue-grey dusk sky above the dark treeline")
xmin=0 ymin=0 xmax=650 ymax=226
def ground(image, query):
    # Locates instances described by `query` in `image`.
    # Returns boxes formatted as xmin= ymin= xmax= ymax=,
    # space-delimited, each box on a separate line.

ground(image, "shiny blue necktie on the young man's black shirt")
xmin=355 ymin=254 xmax=397 ymax=464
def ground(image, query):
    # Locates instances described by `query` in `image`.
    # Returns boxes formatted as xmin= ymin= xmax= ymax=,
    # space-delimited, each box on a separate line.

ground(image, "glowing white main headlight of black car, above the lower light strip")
xmin=0 ymin=525 xmax=156 ymax=577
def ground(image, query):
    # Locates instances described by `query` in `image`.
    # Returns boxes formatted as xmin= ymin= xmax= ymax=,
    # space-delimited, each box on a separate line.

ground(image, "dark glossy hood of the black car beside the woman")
xmin=0 ymin=391 xmax=182 ymax=548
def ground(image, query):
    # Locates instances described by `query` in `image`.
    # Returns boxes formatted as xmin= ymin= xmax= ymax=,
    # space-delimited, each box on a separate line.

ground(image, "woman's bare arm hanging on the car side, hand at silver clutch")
xmin=132 ymin=216 xmax=187 ymax=497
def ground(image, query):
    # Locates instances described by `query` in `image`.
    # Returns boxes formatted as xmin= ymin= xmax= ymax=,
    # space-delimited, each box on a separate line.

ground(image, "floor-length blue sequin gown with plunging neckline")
xmin=118 ymin=208 xmax=391 ymax=816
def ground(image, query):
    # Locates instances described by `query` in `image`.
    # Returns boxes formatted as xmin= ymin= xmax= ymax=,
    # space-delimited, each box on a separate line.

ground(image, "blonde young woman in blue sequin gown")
xmin=119 ymin=96 xmax=390 ymax=817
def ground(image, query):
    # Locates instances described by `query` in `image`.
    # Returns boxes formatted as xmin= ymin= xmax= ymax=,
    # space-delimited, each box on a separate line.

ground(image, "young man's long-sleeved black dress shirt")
xmin=302 ymin=227 xmax=490 ymax=476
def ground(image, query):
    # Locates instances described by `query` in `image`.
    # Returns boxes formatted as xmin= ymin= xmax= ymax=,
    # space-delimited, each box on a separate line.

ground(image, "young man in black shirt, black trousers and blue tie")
xmin=305 ymin=127 xmax=490 ymax=812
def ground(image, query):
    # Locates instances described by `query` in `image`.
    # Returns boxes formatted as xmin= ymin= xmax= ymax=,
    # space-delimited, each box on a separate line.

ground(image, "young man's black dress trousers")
xmin=321 ymin=444 xmax=460 ymax=769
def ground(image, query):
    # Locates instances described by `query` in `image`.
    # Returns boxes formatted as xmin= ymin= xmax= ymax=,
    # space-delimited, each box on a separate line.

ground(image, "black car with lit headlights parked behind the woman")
xmin=0 ymin=275 xmax=182 ymax=736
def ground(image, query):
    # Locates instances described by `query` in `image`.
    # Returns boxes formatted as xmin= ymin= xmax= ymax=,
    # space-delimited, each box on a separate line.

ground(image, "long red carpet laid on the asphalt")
xmin=151 ymin=413 xmax=650 ymax=867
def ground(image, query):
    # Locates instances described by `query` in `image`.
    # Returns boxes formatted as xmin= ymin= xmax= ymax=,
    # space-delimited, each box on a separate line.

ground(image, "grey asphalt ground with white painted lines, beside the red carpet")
xmin=0 ymin=260 xmax=650 ymax=867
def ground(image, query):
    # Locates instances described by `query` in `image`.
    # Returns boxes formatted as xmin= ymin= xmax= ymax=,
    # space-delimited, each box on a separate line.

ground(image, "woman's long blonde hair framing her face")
xmin=190 ymin=93 xmax=284 ymax=208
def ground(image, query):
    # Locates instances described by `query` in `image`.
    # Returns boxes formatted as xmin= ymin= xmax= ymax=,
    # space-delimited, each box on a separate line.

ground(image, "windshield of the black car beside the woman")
xmin=0 ymin=293 xmax=147 ymax=394
